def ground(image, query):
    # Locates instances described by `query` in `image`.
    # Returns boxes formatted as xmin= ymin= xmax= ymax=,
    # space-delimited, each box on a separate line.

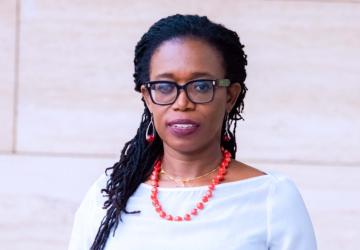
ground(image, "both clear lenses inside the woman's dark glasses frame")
xmin=151 ymin=80 xmax=214 ymax=104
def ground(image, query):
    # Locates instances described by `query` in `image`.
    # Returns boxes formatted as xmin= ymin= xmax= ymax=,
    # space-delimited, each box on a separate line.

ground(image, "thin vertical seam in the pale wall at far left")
xmin=12 ymin=0 xmax=21 ymax=154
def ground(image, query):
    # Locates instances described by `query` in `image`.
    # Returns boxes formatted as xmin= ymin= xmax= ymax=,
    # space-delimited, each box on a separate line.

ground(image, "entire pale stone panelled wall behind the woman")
xmin=0 ymin=0 xmax=360 ymax=250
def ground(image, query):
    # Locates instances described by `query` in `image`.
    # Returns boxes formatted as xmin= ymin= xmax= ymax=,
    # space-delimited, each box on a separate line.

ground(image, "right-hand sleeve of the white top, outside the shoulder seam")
xmin=255 ymin=172 xmax=316 ymax=249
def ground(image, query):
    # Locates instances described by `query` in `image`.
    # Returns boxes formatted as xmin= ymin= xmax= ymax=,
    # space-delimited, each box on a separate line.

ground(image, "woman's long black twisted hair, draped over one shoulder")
xmin=91 ymin=14 xmax=247 ymax=250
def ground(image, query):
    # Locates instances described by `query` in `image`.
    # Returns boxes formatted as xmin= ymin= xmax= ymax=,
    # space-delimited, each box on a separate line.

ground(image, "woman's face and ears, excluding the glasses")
xmin=142 ymin=38 xmax=240 ymax=153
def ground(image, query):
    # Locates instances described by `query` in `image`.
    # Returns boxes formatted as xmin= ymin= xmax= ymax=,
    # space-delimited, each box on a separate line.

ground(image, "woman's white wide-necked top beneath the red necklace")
xmin=69 ymin=172 xmax=317 ymax=250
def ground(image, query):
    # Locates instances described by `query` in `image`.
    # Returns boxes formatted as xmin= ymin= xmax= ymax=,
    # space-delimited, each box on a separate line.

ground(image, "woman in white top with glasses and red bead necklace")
xmin=70 ymin=15 xmax=316 ymax=250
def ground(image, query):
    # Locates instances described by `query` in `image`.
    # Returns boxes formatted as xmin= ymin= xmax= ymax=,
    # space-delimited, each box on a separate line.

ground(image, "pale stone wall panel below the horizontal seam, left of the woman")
xmin=0 ymin=155 xmax=112 ymax=250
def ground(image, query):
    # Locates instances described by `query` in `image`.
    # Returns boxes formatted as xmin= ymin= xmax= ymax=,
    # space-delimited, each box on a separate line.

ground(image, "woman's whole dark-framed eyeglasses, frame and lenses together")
xmin=145 ymin=79 xmax=230 ymax=105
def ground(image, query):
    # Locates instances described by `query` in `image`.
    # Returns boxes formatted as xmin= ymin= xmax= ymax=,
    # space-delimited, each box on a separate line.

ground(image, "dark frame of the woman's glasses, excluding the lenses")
xmin=144 ymin=79 xmax=230 ymax=106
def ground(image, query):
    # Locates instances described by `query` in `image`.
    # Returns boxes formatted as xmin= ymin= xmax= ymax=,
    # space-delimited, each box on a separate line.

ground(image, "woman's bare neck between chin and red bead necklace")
xmin=162 ymin=145 xmax=222 ymax=180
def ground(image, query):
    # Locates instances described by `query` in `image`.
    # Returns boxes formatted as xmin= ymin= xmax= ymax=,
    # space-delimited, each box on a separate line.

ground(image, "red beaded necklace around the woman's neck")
xmin=150 ymin=147 xmax=231 ymax=221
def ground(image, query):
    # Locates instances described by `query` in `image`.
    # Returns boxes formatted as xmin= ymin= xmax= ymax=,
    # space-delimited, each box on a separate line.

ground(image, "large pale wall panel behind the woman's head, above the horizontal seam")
xmin=19 ymin=0 xmax=360 ymax=165
